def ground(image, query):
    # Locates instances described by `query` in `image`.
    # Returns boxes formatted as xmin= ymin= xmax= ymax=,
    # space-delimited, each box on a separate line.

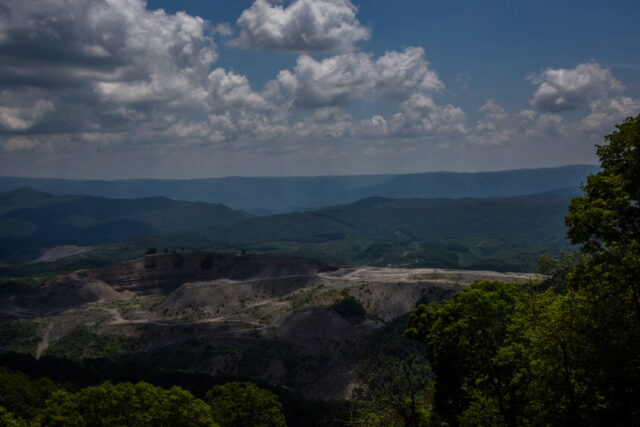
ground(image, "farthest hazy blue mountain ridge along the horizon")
xmin=0 ymin=165 xmax=599 ymax=214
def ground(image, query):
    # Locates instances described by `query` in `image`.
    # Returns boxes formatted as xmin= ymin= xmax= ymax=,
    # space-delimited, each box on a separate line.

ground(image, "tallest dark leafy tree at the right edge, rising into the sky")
xmin=566 ymin=115 xmax=640 ymax=422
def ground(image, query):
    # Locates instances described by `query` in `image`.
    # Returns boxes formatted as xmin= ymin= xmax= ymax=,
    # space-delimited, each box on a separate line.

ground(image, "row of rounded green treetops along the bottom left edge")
xmin=0 ymin=367 xmax=286 ymax=427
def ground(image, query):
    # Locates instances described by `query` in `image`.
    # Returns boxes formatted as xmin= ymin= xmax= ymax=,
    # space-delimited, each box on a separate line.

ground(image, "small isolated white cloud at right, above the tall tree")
xmin=529 ymin=62 xmax=625 ymax=112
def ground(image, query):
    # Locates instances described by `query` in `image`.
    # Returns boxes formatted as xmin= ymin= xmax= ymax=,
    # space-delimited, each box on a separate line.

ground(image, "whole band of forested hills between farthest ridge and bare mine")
xmin=0 ymin=186 xmax=570 ymax=270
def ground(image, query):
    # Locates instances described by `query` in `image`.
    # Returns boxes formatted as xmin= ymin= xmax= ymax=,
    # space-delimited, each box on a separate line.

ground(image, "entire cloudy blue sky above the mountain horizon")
xmin=0 ymin=0 xmax=640 ymax=179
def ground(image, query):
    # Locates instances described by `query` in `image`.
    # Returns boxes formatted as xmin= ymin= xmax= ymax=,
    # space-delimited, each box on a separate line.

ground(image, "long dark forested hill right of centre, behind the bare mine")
xmin=205 ymin=195 xmax=570 ymax=242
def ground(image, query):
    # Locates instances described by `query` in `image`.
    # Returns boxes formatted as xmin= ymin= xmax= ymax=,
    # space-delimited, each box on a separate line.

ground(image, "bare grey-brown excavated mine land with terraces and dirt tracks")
xmin=0 ymin=253 xmax=531 ymax=399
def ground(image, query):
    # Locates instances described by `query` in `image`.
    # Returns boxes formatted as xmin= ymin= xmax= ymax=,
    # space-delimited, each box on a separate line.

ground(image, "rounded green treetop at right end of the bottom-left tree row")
xmin=207 ymin=382 xmax=286 ymax=427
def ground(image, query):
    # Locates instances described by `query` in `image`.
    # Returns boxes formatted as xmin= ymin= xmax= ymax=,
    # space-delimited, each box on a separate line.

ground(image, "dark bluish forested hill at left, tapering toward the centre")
xmin=0 ymin=188 xmax=250 ymax=261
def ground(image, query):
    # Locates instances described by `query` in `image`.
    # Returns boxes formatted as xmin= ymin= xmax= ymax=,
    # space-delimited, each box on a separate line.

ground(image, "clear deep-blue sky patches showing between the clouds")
xmin=148 ymin=0 xmax=640 ymax=113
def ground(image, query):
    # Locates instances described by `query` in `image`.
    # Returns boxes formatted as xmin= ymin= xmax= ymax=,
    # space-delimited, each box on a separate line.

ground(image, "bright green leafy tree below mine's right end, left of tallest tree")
xmin=406 ymin=281 xmax=520 ymax=425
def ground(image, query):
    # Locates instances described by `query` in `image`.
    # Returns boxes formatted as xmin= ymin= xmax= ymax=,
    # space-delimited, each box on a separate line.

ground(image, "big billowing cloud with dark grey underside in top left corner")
xmin=0 ymin=0 xmax=217 ymax=92
